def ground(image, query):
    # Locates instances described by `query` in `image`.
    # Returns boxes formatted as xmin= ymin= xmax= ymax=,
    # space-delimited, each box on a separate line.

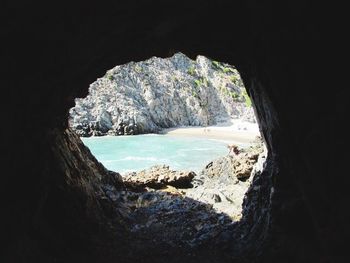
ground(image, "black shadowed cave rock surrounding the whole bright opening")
xmin=0 ymin=0 xmax=344 ymax=263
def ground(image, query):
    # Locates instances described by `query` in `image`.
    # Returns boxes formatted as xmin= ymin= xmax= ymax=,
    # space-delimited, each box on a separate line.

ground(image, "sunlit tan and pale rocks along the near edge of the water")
xmin=122 ymin=141 xmax=267 ymax=223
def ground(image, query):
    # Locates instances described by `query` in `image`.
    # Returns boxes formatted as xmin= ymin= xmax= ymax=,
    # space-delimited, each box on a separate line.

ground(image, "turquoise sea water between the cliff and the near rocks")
xmin=81 ymin=134 xmax=228 ymax=174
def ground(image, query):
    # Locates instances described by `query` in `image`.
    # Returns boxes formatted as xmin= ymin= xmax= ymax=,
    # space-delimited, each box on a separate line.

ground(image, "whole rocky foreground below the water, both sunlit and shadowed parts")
xmin=98 ymin=140 xmax=266 ymax=262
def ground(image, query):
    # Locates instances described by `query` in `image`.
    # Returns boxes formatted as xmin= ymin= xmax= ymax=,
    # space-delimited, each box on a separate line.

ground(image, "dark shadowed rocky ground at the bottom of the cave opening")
xmin=123 ymin=187 xmax=232 ymax=250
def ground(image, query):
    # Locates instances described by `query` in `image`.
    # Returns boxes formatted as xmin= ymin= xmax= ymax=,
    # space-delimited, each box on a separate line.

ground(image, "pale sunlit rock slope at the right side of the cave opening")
xmin=186 ymin=142 xmax=266 ymax=221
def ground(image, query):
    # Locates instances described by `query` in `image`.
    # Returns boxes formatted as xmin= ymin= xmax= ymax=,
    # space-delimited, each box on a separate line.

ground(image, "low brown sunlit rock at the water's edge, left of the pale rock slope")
xmin=123 ymin=165 xmax=196 ymax=189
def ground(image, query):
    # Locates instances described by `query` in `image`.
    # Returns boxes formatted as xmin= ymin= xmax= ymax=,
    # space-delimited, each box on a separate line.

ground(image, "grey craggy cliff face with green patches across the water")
xmin=70 ymin=53 xmax=255 ymax=136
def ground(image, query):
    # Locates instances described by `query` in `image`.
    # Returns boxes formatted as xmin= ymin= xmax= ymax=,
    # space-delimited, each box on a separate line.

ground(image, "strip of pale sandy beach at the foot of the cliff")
xmin=160 ymin=120 xmax=260 ymax=144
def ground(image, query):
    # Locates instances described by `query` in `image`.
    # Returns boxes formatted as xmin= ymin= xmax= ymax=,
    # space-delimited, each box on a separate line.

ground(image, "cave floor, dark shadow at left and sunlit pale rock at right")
xmin=94 ymin=140 xmax=264 ymax=261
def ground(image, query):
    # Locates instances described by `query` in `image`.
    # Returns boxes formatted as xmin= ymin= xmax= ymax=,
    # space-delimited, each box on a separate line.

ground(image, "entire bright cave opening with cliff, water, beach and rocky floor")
xmin=69 ymin=52 xmax=267 ymax=254
